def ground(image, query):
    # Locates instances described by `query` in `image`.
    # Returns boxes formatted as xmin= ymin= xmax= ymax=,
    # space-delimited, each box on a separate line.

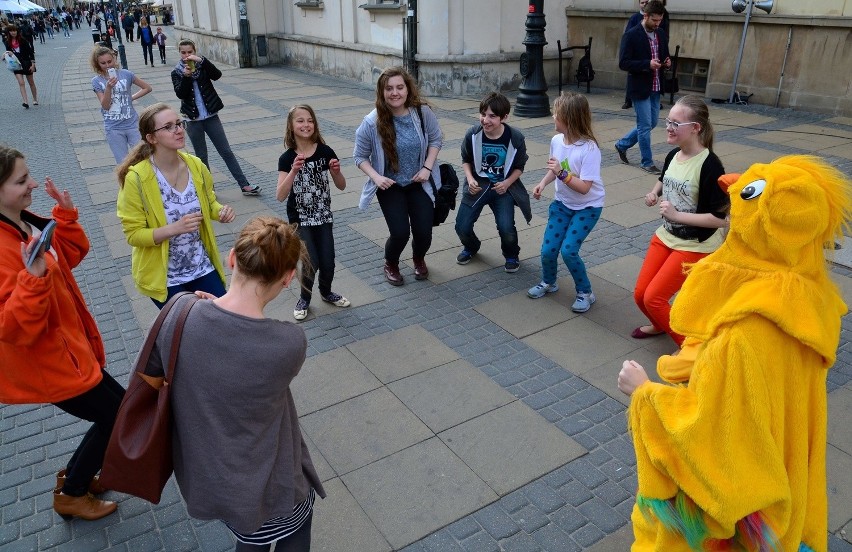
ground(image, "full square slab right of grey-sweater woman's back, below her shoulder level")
xmin=301 ymin=387 xmax=434 ymax=475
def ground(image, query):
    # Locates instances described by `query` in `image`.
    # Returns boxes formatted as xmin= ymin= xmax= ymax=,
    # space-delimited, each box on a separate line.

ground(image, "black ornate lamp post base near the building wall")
xmin=515 ymin=0 xmax=550 ymax=117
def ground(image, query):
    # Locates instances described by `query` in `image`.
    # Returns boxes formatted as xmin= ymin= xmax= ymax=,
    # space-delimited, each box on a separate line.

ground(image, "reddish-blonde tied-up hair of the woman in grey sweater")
xmin=234 ymin=217 xmax=309 ymax=285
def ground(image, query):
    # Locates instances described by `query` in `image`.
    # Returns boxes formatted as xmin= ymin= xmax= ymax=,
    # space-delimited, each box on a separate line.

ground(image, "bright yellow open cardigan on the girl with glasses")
xmin=117 ymin=152 xmax=230 ymax=302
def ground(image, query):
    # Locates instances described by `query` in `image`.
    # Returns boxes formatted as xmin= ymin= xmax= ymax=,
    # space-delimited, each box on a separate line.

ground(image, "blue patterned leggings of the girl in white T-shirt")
xmin=541 ymin=201 xmax=603 ymax=293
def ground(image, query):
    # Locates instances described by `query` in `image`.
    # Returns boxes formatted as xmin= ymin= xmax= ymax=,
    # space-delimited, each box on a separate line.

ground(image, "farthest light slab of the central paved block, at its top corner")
xmin=346 ymin=325 xmax=459 ymax=384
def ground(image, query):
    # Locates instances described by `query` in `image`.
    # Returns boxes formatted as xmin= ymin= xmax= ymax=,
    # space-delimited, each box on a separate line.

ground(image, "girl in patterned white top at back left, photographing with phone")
xmin=89 ymin=46 xmax=151 ymax=163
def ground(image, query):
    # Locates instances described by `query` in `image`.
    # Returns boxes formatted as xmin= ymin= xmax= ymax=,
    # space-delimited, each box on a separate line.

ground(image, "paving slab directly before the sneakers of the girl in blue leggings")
xmin=475 ymin=288 xmax=577 ymax=338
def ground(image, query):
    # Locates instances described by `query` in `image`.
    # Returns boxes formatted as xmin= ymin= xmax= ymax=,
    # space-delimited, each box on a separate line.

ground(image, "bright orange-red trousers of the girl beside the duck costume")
xmin=633 ymin=235 xmax=708 ymax=347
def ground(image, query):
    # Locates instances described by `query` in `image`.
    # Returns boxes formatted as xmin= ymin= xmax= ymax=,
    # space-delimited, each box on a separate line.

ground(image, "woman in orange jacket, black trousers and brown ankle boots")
xmin=0 ymin=145 xmax=124 ymax=520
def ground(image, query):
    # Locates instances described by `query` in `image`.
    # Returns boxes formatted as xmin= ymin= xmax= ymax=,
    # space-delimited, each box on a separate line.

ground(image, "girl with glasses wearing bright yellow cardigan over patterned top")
xmin=117 ymin=103 xmax=235 ymax=308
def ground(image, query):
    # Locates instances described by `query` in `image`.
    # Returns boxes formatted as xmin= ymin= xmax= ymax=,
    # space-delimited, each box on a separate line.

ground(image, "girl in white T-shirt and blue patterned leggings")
xmin=527 ymin=92 xmax=604 ymax=312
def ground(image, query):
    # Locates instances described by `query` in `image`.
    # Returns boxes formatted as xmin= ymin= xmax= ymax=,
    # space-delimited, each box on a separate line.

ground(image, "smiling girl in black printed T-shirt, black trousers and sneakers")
xmin=276 ymin=105 xmax=350 ymax=320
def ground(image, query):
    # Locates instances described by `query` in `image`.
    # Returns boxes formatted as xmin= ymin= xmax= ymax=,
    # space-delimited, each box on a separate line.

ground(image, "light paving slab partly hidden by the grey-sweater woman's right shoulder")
xmin=290 ymin=347 xmax=382 ymax=416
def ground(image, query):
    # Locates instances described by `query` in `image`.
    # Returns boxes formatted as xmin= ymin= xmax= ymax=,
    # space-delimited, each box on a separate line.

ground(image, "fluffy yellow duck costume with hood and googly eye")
xmin=628 ymin=156 xmax=852 ymax=552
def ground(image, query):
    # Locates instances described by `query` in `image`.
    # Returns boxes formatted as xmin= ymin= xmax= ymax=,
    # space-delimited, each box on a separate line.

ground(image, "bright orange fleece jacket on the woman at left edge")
xmin=0 ymin=205 xmax=106 ymax=404
